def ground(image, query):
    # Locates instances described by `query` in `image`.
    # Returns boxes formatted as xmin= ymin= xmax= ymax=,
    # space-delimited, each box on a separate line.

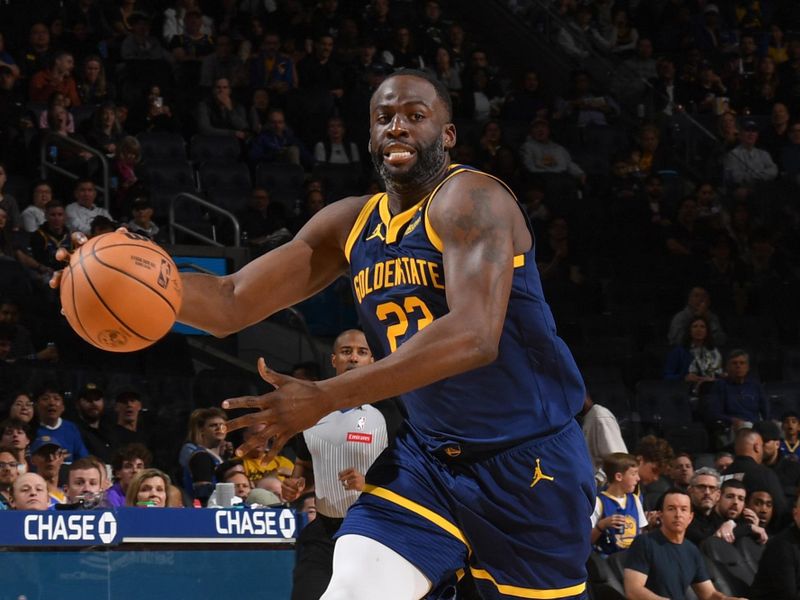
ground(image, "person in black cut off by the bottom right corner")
xmin=749 ymin=496 xmax=800 ymax=600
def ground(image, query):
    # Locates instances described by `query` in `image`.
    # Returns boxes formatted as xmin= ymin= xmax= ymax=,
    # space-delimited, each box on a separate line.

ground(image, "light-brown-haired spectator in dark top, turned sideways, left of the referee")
xmin=183 ymin=408 xmax=233 ymax=506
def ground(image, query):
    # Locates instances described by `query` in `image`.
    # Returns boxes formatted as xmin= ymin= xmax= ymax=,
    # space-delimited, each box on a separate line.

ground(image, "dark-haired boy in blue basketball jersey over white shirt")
xmin=592 ymin=452 xmax=647 ymax=556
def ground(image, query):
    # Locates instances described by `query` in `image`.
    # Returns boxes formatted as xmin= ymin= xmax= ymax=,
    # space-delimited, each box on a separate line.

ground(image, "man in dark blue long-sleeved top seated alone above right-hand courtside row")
xmin=709 ymin=350 xmax=769 ymax=432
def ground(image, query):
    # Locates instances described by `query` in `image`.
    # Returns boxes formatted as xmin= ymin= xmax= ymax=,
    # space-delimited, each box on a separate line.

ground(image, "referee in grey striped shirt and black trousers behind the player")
xmin=281 ymin=329 xmax=403 ymax=600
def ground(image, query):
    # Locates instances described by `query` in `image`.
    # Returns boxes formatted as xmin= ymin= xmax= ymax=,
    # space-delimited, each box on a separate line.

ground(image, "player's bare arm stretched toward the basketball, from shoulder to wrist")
xmin=178 ymin=197 xmax=366 ymax=337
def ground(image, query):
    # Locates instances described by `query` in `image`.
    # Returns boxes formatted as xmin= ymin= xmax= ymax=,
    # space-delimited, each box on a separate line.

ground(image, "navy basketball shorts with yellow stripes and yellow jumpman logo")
xmin=337 ymin=421 xmax=595 ymax=599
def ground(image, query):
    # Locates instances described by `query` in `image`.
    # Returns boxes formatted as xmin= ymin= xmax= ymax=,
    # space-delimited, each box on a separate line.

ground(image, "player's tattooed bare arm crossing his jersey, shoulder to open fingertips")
xmin=223 ymin=174 xmax=532 ymax=452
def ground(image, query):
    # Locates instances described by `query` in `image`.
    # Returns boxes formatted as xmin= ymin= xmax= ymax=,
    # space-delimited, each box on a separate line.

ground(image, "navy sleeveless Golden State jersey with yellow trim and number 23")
xmin=345 ymin=165 xmax=584 ymax=447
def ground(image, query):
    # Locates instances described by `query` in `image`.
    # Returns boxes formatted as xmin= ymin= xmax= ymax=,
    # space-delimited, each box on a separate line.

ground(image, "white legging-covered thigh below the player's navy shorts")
xmin=321 ymin=535 xmax=431 ymax=600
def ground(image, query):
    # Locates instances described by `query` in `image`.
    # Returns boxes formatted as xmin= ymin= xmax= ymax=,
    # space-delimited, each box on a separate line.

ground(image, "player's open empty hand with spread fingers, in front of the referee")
xmin=222 ymin=358 xmax=330 ymax=461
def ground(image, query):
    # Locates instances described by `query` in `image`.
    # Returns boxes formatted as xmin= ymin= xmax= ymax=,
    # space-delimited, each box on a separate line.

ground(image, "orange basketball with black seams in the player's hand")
xmin=61 ymin=231 xmax=182 ymax=352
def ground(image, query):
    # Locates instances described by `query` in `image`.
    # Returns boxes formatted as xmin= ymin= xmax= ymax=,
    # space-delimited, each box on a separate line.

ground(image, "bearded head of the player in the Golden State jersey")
xmin=370 ymin=75 xmax=456 ymax=185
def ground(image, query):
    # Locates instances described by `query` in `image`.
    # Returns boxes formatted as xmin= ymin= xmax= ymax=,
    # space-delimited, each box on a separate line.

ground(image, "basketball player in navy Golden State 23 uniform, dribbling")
xmin=59 ymin=71 xmax=594 ymax=600
